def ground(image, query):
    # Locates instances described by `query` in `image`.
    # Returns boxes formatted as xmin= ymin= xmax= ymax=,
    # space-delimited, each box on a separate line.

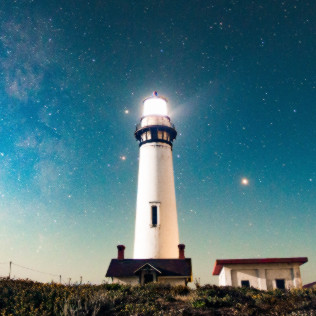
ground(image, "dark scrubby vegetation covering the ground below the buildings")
xmin=0 ymin=279 xmax=316 ymax=316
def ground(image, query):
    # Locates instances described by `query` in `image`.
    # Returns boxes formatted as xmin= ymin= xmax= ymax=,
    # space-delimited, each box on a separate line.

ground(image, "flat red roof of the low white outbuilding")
xmin=213 ymin=257 xmax=308 ymax=275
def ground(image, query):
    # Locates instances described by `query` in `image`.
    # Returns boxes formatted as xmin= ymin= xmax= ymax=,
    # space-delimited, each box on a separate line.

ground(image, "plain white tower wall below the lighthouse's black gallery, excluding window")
xmin=134 ymin=143 xmax=179 ymax=259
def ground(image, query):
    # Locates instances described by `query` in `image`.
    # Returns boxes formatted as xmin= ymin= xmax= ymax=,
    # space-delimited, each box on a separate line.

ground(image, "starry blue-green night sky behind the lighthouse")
xmin=0 ymin=0 xmax=316 ymax=284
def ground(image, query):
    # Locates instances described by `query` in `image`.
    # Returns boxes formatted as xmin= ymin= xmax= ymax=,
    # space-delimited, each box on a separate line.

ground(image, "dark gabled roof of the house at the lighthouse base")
xmin=105 ymin=258 xmax=192 ymax=277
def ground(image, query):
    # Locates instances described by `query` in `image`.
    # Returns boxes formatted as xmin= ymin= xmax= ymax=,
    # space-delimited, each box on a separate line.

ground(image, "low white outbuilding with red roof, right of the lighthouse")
xmin=213 ymin=257 xmax=308 ymax=290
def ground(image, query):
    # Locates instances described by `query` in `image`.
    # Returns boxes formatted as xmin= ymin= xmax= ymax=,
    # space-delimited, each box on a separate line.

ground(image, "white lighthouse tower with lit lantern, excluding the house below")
xmin=134 ymin=91 xmax=179 ymax=259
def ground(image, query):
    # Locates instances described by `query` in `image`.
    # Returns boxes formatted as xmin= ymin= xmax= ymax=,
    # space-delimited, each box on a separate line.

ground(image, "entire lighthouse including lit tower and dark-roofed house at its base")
xmin=106 ymin=91 xmax=192 ymax=285
